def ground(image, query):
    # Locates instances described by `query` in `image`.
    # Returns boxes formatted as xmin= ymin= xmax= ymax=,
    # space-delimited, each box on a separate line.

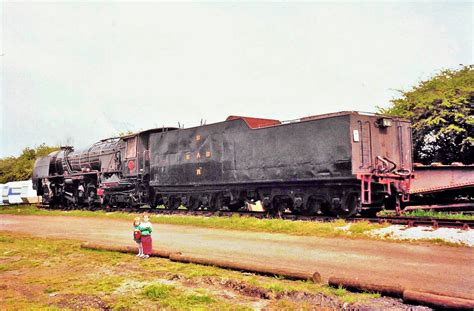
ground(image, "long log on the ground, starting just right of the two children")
xmin=169 ymin=253 xmax=321 ymax=283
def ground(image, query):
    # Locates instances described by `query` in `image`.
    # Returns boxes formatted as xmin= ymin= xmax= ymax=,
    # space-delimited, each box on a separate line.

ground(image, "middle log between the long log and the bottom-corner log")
xmin=328 ymin=277 xmax=404 ymax=298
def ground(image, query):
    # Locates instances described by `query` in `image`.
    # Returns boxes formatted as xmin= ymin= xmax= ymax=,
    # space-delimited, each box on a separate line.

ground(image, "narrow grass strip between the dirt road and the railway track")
xmin=0 ymin=205 xmax=387 ymax=238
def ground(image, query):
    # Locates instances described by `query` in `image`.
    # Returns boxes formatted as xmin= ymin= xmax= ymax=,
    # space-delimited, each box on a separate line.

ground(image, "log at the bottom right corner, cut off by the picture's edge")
xmin=403 ymin=289 xmax=474 ymax=310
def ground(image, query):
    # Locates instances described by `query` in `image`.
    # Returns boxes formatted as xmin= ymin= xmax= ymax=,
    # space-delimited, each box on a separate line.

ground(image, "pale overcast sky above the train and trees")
xmin=0 ymin=1 xmax=473 ymax=157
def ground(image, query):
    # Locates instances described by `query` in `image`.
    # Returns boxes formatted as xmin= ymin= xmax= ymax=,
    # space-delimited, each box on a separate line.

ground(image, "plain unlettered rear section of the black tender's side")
xmin=234 ymin=115 xmax=351 ymax=181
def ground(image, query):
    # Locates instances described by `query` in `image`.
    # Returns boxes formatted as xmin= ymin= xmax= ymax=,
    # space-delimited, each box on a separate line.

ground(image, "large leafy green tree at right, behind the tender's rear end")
xmin=379 ymin=65 xmax=474 ymax=164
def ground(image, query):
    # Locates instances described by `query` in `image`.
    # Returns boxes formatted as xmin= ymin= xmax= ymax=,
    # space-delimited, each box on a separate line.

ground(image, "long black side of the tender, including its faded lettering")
xmin=150 ymin=115 xmax=351 ymax=186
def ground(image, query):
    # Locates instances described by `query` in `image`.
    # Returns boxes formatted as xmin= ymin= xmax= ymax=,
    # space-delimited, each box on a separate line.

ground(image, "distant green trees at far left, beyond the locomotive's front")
xmin=0 ymin=144 xmax=59 ymax=184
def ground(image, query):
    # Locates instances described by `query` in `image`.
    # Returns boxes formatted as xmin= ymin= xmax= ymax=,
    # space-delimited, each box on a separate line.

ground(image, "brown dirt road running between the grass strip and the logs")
xmin=0 ymin=215 xmax=474 ymax=299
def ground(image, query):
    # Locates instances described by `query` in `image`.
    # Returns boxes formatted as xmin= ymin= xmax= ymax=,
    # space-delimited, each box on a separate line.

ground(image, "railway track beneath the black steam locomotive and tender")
xmin=39 ymin=205 xmax=474 ymax=230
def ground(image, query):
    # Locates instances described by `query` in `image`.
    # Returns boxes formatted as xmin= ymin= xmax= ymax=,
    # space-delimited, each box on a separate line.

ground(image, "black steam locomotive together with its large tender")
xmin=32 ymin=111 xmax=412 ymax=217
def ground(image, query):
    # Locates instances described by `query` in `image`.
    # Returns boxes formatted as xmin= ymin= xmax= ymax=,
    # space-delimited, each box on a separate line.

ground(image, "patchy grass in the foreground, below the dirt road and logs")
xmin=0 ymin=232 xmax=379 ymax=310
